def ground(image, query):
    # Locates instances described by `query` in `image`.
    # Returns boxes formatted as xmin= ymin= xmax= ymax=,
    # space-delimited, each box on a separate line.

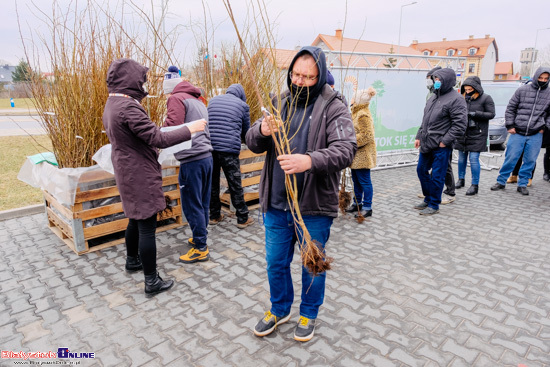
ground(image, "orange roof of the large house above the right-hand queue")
xmin=410 ymin=34 xmax=498 ymax=61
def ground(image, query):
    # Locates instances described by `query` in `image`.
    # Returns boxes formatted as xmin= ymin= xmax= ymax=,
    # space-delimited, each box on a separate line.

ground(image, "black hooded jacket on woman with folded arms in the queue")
xmin=455 ymin=76 xmax=495 ymax=152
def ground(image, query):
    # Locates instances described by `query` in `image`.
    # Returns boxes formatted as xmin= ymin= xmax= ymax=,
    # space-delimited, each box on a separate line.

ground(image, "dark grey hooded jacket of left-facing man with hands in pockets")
xmin=416 ymin=68 xmax=468 ymax=153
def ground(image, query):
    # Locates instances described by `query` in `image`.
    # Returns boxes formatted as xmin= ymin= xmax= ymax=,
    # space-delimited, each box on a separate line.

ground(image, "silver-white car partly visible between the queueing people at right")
xmin=481 ymin=82 xmax=523 ymax=150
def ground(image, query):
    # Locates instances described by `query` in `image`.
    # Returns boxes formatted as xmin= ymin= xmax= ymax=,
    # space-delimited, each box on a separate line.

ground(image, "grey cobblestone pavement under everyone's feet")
xmin=0 ymin=158 xmax=550 ymax=367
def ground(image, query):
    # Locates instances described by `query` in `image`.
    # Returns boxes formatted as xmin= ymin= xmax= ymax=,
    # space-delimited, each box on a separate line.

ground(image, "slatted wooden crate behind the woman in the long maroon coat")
xmin=43 ymin=166 xmax=184 ymax=255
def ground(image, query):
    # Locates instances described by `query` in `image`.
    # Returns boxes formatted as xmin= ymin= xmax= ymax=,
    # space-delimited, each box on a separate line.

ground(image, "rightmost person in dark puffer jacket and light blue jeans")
xmin=491 ymin=66 xmax=550 ymax=195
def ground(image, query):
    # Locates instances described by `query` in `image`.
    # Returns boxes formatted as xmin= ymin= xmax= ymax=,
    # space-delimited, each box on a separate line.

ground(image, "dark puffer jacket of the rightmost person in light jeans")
xmin=504 ymin=66 xmax=550 ymax=136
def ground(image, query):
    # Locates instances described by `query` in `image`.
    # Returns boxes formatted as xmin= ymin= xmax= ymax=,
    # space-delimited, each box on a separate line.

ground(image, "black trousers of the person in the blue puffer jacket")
xmin=210 ymin=151 xmax=248 ymax=224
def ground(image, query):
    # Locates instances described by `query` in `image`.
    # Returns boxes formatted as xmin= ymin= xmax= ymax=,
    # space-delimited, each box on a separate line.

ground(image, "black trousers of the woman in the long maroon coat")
xmin=125 ymin=214 xmax=157 ymax=275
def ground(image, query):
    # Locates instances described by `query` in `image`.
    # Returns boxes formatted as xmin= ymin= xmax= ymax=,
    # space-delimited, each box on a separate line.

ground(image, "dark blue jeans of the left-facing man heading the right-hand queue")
xmin=416 ymin=147 xmax=453 ymax=210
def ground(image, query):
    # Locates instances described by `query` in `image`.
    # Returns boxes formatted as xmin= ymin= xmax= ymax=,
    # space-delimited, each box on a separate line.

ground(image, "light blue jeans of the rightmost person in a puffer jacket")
xmin=497 ymin=133 xmax=542 ymax=187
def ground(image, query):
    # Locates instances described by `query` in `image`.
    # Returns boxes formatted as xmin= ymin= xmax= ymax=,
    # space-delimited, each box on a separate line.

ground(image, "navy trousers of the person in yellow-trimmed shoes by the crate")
xmin=179 ymin=156 xmax=212 ymax=250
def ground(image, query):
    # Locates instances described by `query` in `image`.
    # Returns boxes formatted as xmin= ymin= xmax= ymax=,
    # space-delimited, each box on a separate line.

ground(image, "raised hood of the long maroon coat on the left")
xmin=107 ymin=59 xmax=149 ymax=102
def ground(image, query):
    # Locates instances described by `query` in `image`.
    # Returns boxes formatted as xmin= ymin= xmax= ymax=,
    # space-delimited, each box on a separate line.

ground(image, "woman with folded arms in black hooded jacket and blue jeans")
xmin=455 ymin=76 xmax=495 ymax=195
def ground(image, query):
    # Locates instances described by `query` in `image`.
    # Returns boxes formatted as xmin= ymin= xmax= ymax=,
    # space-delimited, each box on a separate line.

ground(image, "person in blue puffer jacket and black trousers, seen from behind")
xmin=208 ymin=84 xmax=254 ymax=228
